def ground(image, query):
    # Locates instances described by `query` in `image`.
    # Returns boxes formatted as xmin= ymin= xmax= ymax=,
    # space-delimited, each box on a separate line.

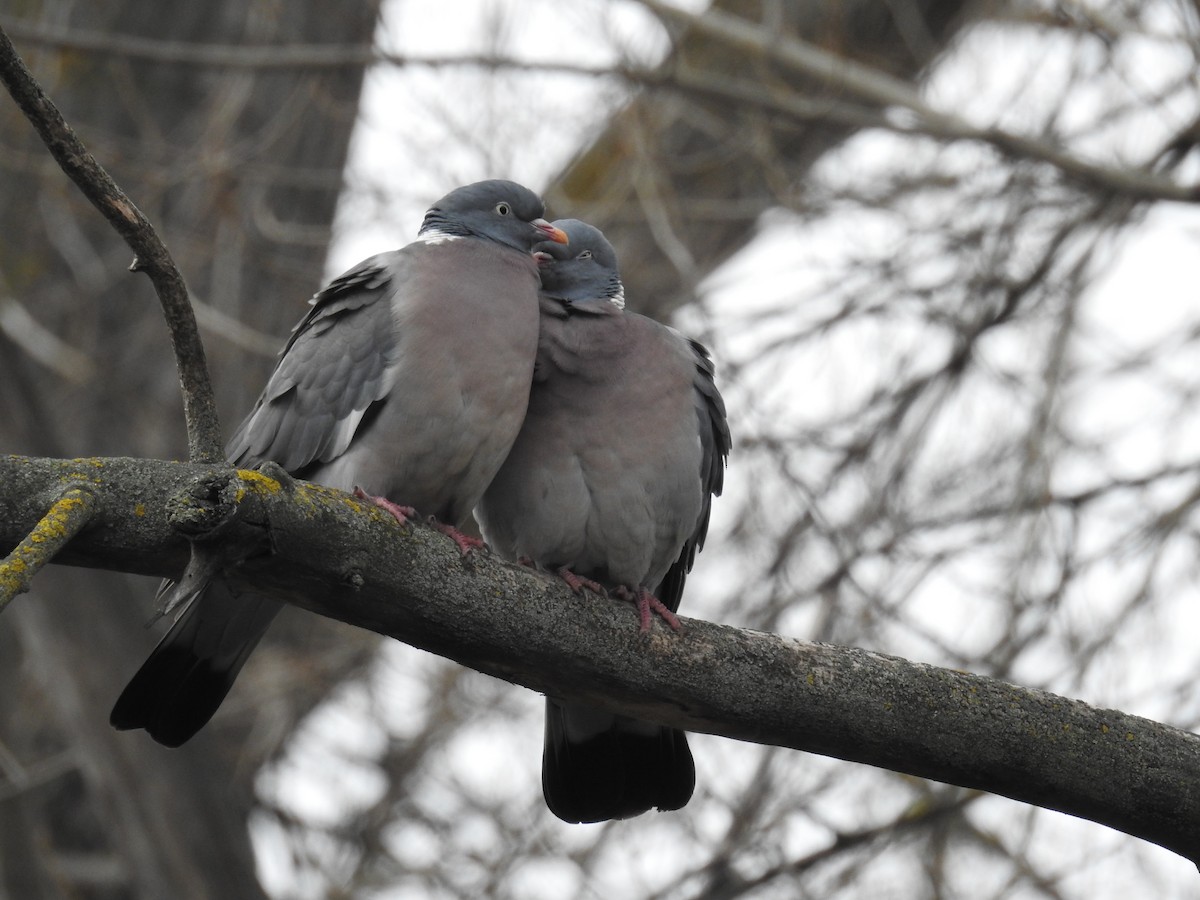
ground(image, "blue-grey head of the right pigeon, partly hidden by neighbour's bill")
xmin=533 ymin=218 xmax=625 ymax=308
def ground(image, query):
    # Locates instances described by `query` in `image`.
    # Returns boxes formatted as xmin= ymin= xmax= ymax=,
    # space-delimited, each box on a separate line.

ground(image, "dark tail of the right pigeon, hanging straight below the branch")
xmin=541 ymin=697 xmax=696 ymax=822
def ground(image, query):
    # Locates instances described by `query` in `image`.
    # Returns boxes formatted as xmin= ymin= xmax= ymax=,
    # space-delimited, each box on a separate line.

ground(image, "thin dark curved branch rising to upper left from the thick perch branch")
xmin=0 ymin=29 xmax=224 ymax=462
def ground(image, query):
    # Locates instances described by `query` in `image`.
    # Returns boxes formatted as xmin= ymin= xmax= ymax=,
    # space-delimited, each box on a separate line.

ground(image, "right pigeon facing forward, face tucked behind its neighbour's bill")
xmin=475 ymin=220 xmax=730 ymax=822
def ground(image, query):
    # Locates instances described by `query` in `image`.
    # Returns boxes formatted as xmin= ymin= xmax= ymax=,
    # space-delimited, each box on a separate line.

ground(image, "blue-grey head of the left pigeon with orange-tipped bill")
xmin=419 ymin=179 xmax=566 ymax=253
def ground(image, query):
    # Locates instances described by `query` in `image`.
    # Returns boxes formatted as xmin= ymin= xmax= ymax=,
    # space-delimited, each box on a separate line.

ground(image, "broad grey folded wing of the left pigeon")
xmin=226 ymin=251 xmax=403 ymax=475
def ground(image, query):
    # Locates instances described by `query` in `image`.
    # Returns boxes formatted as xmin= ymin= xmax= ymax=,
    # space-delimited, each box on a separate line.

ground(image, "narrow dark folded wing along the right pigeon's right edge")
xmin=655 ymin=340 xmax=732 ymax=611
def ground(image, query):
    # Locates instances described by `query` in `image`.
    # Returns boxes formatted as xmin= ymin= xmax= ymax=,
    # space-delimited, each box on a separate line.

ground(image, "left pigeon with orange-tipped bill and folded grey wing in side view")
xmin=110 ymin=180 xmax=566 ymax=746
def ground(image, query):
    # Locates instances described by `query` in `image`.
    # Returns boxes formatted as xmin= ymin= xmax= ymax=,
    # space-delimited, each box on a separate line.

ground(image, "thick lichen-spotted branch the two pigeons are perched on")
xmin=0 ymin=456 xmax=1200 ymax=862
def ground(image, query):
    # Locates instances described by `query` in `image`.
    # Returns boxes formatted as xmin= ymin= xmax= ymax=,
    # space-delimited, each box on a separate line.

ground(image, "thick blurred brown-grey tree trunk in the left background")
xmin=0 ymin=0 xmax=378 ymax=898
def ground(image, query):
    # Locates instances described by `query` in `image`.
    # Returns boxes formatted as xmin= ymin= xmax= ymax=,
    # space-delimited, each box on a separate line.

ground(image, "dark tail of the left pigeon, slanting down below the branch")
xmin=108 ymin=578 xmax=282 ymax=746
